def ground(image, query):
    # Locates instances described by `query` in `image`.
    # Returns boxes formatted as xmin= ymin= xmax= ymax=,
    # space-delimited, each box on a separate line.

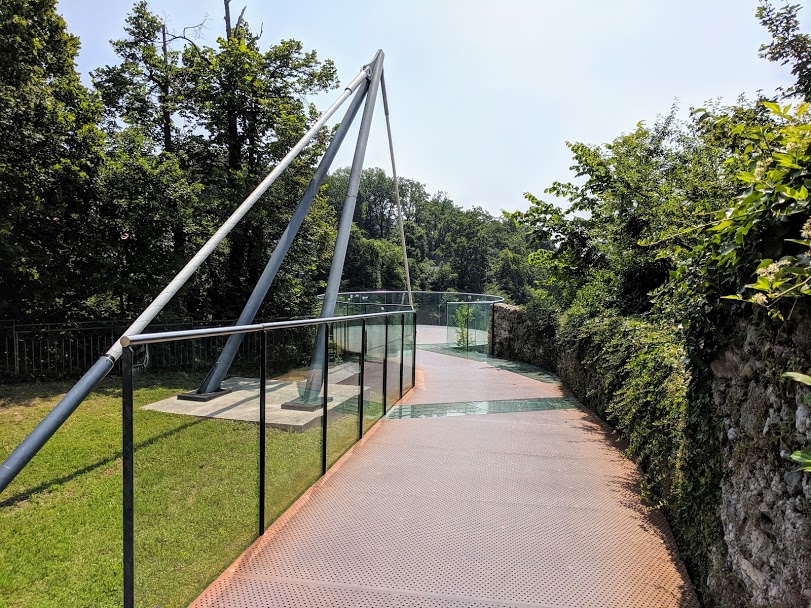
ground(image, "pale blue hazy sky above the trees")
xmin=58 ymin=0 xmax=805 ymax=213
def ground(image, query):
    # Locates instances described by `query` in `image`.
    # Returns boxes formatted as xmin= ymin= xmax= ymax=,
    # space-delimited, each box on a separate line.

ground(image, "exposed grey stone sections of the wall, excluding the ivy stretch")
xmin=494 ymin=305 xmax=811 ymax=608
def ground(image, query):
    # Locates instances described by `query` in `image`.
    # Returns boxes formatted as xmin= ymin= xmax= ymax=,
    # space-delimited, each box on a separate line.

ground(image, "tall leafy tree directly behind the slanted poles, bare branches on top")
xmin=180 ymin=9 xmax=336 ymax=317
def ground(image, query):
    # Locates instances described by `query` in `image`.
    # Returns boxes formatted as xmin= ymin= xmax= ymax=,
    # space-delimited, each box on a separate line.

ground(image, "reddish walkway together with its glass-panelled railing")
xmin=112 ymin=292 xmax=698 ymax=608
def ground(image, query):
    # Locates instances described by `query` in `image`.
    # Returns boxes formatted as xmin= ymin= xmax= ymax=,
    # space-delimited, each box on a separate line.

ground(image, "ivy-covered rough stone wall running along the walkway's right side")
xmin=494 ymin=305 xmax=811 ymax=607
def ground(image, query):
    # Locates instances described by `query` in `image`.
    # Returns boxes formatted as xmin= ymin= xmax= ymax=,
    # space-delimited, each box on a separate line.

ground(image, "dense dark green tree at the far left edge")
xmin=0 ymin=0 xmax=103 ymax=319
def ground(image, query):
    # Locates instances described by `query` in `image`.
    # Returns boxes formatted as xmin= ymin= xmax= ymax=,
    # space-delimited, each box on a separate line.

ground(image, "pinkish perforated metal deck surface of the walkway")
xmin=193 ymin=352 xmax=698 ymax=608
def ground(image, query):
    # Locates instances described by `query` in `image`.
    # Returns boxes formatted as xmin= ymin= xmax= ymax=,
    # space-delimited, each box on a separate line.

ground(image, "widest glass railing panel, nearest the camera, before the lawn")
xmin=133 ymin=334 xmax=261 ymax=608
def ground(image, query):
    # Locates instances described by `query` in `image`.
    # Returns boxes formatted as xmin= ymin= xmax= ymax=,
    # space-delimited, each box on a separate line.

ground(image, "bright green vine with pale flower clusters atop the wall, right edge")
xmin=696 ymin=102 xmax=811 ymax=319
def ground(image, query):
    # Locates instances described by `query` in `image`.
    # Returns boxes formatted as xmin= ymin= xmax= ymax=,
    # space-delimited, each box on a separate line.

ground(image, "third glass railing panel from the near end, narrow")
xmin=327 ymin=321 xmax=363 ymax=467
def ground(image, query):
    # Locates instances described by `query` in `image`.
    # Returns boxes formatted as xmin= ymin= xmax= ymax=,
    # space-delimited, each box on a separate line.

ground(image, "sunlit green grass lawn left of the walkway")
xmin=0 ymin=374 xmax=373 ymax=608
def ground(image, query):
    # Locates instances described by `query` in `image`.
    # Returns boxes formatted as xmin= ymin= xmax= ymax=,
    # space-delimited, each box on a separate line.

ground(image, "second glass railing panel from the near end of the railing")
xmin=265 ymin=326 xmax=326 ymax=527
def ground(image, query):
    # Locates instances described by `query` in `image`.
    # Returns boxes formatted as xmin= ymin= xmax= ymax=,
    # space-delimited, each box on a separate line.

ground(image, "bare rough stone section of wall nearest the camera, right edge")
xmin=710 ymin=321 xmax=811 ymax=607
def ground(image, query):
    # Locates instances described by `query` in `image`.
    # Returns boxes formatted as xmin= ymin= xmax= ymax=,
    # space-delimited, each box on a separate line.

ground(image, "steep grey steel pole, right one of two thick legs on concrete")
xmin=302 ymin=50 xmax=384 ymax=401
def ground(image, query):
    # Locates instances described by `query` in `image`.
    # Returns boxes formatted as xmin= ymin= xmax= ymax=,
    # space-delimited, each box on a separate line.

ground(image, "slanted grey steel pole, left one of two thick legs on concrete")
xmin=197 ymin=76 xmax=369 ymax=394
